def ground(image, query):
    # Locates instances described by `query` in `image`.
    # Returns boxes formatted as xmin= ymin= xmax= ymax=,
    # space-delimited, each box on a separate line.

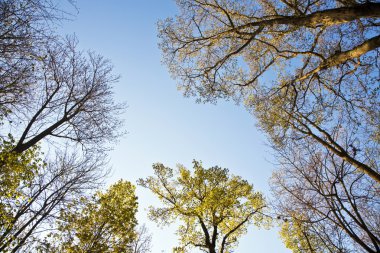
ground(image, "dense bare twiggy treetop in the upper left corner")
xmin=0 ymin=0 xmax=70 ymax=118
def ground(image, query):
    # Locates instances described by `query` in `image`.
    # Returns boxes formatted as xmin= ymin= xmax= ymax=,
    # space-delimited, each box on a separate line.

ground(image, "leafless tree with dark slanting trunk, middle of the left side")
xmin=7 ymin=37 xmax=124 ymax=153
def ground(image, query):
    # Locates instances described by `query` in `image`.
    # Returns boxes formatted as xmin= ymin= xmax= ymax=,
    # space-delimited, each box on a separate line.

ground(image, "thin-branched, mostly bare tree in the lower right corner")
xmin=272 ymin=141 xmax=380 ymax=253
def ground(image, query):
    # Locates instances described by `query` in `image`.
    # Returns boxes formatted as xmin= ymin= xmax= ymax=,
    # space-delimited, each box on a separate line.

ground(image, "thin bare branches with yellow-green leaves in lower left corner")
xmin=0 ymin=148 xmax=105 ymax=252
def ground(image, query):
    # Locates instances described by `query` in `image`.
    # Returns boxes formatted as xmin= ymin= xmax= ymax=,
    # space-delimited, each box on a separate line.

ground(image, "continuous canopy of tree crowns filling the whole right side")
xmin=158 ymin=0 xmax=380 ymax=252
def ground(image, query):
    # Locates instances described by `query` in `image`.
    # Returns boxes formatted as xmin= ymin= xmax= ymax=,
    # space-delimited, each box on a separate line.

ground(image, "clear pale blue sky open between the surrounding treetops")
xmin=61 ymin=0 xmax=290 ymax=253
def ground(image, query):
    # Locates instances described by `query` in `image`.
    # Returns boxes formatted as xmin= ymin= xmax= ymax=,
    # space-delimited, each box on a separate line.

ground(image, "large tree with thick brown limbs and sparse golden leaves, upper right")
xmin=159 ymin=0 xmax=380 ymax=183
